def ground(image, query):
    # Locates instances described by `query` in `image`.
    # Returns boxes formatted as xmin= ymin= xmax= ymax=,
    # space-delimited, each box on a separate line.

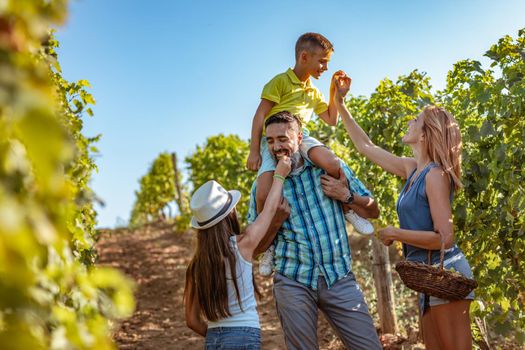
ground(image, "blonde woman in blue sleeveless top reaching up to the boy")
xmin=327 ymin=73 xmax=473 ymax=350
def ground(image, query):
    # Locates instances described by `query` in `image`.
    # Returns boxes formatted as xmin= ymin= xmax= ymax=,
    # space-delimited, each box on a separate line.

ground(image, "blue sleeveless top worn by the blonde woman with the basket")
xmin=396 ymin=163 xmax=461 ymax=264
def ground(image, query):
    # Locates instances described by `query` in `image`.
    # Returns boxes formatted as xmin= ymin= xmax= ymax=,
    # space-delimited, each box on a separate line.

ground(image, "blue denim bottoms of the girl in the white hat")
xmin=204 ymin=327 xmax=261 ymax=350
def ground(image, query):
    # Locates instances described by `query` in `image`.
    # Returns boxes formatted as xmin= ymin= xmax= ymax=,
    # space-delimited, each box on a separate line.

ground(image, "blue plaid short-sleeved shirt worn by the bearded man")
xmin=248 ymin=160 xmax=370 ymax=290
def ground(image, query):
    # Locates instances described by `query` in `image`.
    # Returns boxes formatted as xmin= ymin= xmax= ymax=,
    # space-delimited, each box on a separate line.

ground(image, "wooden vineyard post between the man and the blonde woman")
xmin=372 ymin=238 xmax=398 ymax=334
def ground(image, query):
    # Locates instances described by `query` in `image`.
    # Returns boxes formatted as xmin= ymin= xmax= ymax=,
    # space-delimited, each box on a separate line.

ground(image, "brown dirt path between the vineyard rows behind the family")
xmin=97 ymin=226 xmax=344 ymax=350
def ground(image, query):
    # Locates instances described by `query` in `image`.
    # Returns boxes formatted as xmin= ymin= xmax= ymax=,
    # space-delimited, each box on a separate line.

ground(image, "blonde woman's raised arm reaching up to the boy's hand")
xmin=335 ymin=76 xmax=417 ymax=179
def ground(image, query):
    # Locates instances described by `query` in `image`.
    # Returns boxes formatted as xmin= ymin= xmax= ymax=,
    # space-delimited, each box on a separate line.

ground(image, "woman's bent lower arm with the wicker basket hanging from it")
xmin=379 ymin=168 xmax=454 ymax=250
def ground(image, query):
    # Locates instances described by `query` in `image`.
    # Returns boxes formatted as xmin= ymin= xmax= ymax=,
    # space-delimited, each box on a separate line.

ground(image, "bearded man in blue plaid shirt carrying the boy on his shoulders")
xmin=248 ymin=112 xmax=381 ymax=350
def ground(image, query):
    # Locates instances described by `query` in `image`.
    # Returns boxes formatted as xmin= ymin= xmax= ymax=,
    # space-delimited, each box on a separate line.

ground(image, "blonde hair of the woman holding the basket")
xmin=423 ymin=106 xmax=463 ymax=191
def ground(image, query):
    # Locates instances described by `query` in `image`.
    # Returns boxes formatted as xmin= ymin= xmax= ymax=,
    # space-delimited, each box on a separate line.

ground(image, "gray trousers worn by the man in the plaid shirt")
xmin=273 ymin=272 xmax=382 ymax=350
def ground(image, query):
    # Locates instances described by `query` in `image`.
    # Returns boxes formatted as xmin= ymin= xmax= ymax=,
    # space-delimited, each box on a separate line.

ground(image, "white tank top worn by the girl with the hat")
xmin=208 ymin=236 xmax=261 ymax=328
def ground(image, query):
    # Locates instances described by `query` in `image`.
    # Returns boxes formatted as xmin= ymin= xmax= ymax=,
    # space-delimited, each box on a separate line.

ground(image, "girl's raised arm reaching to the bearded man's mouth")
xmin=238 ymin=157 xmax=291 ymax=261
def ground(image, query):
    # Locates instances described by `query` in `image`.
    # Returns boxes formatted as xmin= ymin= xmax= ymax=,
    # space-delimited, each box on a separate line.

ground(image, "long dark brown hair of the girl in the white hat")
xmin=186 ymin=210 xmax=242 ymax=321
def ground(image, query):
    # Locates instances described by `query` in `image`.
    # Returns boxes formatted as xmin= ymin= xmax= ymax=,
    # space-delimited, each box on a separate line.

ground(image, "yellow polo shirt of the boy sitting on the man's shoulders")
xmin=261 ymin=68 xmax=328 ymax=129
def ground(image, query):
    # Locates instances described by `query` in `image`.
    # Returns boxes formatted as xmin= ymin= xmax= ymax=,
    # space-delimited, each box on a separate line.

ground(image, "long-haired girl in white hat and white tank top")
xmin=184 ymin=156 xmax=291 ymax=350
